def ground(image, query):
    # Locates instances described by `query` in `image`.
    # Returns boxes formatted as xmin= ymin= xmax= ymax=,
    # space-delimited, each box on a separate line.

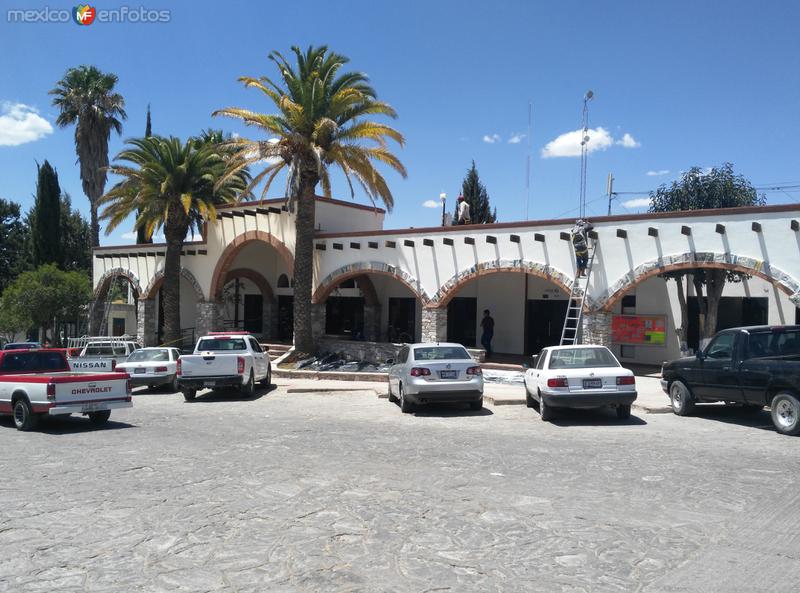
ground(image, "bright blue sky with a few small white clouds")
xmin=0 ymin=0 xmax=800 ymax=244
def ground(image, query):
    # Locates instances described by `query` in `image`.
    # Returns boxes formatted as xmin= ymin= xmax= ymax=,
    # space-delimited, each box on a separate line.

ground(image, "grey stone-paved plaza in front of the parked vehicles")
xmin=0 ymin=381 xmax=800 ymax=593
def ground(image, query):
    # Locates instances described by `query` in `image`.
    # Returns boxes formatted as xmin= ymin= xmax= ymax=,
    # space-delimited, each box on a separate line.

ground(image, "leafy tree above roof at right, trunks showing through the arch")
xmin=650 ymin=163 xmax=766 ymax=347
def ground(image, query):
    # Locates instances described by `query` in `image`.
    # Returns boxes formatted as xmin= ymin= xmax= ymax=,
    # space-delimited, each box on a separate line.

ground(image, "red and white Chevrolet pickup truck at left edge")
xmin=0 ymin=349 xmax=133 ymax=430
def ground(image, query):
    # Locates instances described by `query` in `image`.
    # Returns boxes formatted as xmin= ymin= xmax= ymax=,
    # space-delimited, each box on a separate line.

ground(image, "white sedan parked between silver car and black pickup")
xmin=524 ymin=345 xmax=636 ymax=420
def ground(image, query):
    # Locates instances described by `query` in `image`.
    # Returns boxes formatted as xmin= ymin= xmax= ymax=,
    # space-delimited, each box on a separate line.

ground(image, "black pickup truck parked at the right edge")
xmin=661 ymin=325 xmax=800 ymax=435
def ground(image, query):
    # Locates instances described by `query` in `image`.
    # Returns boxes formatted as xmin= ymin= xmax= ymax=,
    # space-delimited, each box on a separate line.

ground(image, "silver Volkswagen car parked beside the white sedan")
xmin=389 ymin=343 xmax=483 ymax=413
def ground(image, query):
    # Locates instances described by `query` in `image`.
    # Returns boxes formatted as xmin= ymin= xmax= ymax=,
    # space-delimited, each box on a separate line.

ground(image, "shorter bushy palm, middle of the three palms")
xmin=98 ymin=136 xmax=250 ymax=344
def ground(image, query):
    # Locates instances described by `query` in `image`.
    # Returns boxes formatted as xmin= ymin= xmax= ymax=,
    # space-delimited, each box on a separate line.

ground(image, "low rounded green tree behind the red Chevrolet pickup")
xmin=0 ymin=264 xmax=92 ymax=343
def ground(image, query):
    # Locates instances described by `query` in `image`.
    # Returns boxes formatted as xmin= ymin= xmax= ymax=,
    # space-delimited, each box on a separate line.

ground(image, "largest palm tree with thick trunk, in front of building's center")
xmin=214 ymin=46 xmax=406 ymax=352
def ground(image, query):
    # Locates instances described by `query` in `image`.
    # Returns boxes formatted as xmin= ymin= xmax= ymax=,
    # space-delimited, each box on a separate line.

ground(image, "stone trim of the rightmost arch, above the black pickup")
xmin=595 ymin=252 xmax=800 ymax=311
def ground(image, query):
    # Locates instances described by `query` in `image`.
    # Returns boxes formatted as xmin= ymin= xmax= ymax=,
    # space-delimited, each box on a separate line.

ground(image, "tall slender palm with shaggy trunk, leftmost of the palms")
xmin=50 ymin=66 xmax=127 ymax=247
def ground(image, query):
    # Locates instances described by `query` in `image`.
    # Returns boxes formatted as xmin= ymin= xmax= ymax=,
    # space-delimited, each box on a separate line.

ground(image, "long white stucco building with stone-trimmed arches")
xmin=93 ymin=198 xmax=800 ymax=363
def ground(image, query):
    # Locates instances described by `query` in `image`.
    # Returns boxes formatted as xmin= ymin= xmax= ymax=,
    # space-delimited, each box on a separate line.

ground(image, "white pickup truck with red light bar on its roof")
xmin=178 ymin=332 xmax=272 ymax=401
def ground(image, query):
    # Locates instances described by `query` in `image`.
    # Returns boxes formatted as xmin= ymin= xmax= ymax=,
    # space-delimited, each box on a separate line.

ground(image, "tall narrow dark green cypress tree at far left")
xmin=30 ymin=161 xmax=61 ymax=266
